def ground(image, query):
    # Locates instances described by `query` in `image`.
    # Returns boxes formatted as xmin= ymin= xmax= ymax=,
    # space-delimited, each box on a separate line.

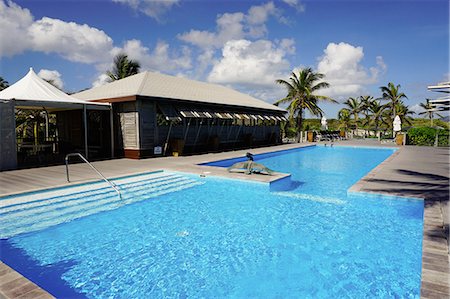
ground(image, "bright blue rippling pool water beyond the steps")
xmin=1 ymin=147 xmax=423 ymax=298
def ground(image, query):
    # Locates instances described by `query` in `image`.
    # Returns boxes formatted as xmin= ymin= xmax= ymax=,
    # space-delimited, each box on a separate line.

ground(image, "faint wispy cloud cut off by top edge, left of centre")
xmin=112 ymin=0 xmax=179 ymax=22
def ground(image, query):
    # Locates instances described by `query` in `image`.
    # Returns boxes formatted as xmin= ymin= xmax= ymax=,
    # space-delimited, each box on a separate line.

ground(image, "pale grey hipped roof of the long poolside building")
xmin=72 ymin=72 xmax=286 ymax=112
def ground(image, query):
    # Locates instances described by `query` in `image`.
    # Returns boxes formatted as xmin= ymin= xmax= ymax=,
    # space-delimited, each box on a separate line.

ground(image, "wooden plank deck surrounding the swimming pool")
xmin=0 ymin=140 xmax=450 ymax=298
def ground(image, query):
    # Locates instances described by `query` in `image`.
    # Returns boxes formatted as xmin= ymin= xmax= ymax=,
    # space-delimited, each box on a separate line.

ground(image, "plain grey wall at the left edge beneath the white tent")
xmin=0 ymin=100 xmax=17 ymax=171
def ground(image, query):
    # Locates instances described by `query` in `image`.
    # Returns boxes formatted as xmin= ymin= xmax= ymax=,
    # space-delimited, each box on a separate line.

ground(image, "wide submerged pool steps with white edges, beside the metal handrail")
xmin=0 ymin=175 xmax=203 ymax=238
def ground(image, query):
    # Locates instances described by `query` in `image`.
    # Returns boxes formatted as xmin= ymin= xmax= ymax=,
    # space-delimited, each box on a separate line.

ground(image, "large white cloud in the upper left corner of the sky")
xmin=0 ymin=1 xmax=113 ymax=63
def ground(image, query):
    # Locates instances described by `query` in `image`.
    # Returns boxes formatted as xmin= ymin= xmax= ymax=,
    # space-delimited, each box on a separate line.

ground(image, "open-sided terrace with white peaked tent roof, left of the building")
xmin=0 ymin=68 xmax=114 ymax=170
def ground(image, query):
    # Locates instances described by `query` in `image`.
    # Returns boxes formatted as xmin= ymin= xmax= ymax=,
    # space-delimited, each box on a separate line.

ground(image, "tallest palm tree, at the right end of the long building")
xmin=275 ymin=68 xmax=336 ymax=142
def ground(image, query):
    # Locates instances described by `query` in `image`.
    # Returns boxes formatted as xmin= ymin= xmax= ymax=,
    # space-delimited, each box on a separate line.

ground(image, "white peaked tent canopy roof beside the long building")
xmin=0 ymin=68 xmax=110 ymax=109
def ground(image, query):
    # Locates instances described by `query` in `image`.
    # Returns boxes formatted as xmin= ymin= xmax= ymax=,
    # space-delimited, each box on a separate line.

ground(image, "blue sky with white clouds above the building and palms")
xmin=0 ymin=0 xmax=450 ymax=118
